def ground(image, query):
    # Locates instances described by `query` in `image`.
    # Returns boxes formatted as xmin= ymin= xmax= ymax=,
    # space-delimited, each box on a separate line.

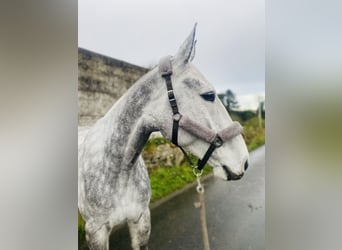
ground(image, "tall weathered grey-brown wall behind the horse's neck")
xmin=78 ymin=48 xmax=148 ymax=126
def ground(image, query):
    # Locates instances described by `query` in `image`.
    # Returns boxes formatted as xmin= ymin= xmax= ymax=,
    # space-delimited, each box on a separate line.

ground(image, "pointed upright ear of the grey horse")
xmin=175 ymin=23 xmax=197 ymax=64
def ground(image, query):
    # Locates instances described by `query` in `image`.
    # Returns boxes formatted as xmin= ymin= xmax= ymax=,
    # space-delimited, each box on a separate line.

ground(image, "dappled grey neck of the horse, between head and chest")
xmin=103 ymin=70 xmax=160 ymax=168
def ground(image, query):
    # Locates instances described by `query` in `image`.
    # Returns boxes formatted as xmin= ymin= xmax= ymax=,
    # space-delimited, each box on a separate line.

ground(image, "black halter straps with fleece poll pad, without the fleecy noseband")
xmin=159 ymin=57 xmax=223 ymax=171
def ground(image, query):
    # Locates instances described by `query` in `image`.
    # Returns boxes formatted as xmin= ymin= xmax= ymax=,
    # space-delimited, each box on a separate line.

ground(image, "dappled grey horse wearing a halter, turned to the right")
xmin=78 ymin=25 xmax=248 ymax=250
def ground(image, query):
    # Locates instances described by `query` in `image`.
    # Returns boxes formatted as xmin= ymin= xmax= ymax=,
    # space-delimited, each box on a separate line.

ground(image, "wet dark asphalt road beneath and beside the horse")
xmin=110 ymin=146 xmax=265 ymax=250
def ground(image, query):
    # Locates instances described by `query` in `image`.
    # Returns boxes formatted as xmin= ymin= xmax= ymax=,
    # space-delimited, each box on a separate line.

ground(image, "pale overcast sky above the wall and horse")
xmin=78 ymin=0 xmax=265 ymax=95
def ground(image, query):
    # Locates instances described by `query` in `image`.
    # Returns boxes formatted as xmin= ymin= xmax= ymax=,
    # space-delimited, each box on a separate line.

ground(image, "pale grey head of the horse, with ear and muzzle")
xmin=155 ymin=25 xmax=248 ymax=180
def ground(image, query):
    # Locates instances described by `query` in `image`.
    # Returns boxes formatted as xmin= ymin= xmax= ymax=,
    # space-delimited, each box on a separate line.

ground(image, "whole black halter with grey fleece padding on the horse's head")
xmin=159 ymin=56 xmax=242 ymax=171
